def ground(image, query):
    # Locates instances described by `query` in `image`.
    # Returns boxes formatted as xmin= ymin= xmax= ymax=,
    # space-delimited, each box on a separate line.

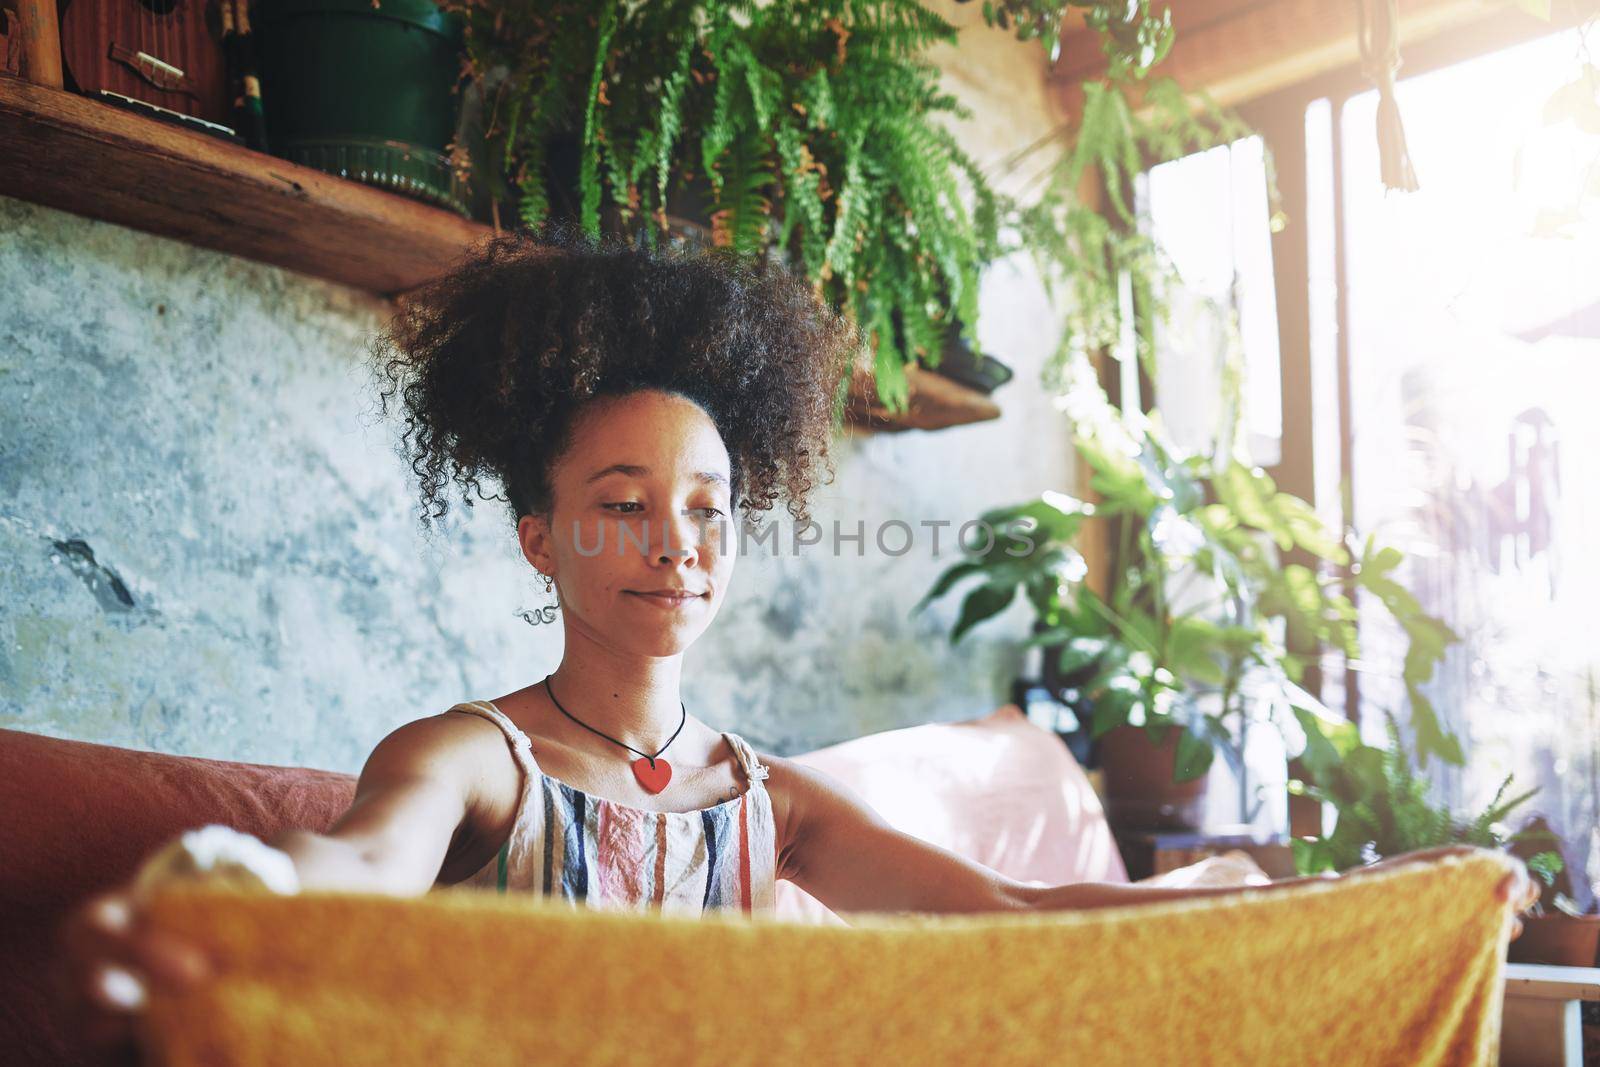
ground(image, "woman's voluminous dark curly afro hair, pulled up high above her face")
xmin=371 ymin=224 xmax=859 ymax=530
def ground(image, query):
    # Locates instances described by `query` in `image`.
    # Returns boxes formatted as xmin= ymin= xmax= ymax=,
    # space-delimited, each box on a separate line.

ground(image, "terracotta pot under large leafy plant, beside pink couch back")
xmin=1099 ymin=726 xmax=1206 ymax=830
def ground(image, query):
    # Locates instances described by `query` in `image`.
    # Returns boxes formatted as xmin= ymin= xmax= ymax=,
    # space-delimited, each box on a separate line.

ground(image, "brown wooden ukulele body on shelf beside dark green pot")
xmin=61 ymin=0 xmax=230 ymax=125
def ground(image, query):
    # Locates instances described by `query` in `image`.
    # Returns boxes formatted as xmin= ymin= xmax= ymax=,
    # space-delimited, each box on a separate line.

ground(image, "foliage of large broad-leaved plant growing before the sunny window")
xmin=917 ymin=368 xmax=1461 ymax=796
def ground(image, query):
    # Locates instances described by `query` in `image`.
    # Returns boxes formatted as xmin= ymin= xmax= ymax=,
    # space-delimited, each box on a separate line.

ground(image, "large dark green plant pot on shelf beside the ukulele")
xmin=254 ymin=0 xmax=469 ymax=214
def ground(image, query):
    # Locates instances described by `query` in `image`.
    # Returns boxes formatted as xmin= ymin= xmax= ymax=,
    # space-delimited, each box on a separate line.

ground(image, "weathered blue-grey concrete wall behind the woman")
xmin=0 ymin=20 xmax=1072 ymax=771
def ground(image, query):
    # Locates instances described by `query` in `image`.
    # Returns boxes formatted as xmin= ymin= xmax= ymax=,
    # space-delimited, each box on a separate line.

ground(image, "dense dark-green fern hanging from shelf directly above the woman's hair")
xmin=442 ymin=0 xmax=1002 ymax=408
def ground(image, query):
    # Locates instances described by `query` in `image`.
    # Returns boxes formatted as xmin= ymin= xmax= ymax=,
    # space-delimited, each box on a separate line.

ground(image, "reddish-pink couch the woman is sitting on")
xmin=0 ymin=705 xmax=1126 ymax=1067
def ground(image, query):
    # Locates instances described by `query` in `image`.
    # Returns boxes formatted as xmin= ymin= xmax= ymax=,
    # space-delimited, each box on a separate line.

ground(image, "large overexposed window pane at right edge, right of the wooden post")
xmin=1307 ymin=32 xmax=1600 ymax=893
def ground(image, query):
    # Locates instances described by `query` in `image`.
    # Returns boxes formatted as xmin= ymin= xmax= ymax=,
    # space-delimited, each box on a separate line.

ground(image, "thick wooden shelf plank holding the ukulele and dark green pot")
xmin=0 ymin=75 xmax=493 ymax=296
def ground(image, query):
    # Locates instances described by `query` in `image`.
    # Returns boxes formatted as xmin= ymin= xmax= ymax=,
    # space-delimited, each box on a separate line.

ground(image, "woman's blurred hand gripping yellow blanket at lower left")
xmin=66 ymin=886 xmax=213 ymax=1051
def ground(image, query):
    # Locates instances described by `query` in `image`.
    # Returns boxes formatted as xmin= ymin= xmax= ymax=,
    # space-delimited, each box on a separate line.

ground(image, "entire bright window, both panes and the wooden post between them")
xmin=1146 ymin=22 xmax=1600 ymax=901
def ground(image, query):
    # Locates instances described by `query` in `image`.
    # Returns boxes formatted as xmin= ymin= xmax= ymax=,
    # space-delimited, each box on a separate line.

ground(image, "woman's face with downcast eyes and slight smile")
xmin=517 ymin=389 xmax=736 ymax=656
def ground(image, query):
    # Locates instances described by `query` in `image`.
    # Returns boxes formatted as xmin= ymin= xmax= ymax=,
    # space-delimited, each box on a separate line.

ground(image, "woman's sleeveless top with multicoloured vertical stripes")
xmin=450 ymin=701 xmax=778 ymax=915
